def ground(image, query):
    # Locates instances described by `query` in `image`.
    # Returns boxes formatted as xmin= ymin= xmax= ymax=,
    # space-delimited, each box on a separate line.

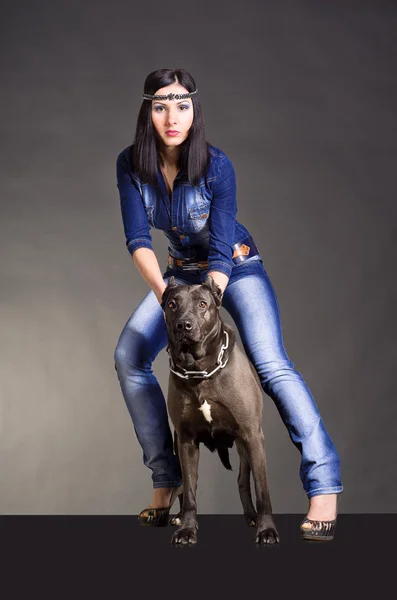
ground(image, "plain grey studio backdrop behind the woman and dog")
xmin=0 ymin=0 xmax=397 ymax=514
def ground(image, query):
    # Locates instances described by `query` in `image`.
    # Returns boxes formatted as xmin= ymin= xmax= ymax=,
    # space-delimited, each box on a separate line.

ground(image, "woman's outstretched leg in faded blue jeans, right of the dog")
xmin=222 ymin=261 xmax=343 ymax=518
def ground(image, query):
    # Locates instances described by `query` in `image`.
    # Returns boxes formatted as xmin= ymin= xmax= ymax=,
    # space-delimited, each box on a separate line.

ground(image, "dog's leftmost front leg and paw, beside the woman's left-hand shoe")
xmin=171 ymin=436 xmax=200 ymax=544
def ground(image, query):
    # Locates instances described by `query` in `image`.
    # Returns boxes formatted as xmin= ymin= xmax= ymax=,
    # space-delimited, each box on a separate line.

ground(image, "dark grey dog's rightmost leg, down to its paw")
xmin=243 ymin=430 xmax=280 ymax=544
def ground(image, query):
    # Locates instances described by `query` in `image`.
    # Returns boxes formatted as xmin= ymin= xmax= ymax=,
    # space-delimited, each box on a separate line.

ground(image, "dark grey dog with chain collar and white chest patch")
xmin=161 ymin=276 xmax=279 ymax=544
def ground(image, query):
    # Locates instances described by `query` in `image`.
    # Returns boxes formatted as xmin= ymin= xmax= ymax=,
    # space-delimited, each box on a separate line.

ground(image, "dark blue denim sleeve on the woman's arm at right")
xmin=208 ymin=156 xmax=237 ymax=277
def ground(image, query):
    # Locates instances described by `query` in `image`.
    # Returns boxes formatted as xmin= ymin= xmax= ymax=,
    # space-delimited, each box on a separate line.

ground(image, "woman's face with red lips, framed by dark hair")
xmin=152 ymin=83 xmax=194 ymax=147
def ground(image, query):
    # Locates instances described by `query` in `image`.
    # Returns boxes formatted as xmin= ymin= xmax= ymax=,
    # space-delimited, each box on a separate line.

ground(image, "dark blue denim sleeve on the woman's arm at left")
xmin=116 ymin=152 xmax=153 ymax=255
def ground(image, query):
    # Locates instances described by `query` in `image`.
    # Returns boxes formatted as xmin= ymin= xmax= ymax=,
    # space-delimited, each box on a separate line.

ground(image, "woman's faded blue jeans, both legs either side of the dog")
xmin=114 ymin=259 xmax=343 ymax=498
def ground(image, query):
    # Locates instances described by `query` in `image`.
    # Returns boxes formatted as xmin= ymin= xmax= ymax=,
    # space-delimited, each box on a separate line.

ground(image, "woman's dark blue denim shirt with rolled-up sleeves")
xmin=116 ymin=145 xmax=260 ymax=277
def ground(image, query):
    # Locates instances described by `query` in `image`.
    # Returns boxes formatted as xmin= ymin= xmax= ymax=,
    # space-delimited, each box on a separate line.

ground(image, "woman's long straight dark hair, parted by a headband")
xmin=131 ymin=69 xmax=210 ymax=185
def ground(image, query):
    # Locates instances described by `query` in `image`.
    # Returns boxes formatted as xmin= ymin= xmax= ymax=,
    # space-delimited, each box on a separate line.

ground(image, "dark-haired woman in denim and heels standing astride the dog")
xmin=115 ymin=69 xmax=343 ymax=539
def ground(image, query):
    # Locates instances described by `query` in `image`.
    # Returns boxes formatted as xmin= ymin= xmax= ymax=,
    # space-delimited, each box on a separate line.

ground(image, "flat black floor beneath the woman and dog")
xmin=0 ymin=514 xmax=397 ymax=600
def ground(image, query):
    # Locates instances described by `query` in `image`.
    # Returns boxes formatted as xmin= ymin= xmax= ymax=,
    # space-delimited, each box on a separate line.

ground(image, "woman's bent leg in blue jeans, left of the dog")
xmin=114 ymin=279 xmax=186 ymax=488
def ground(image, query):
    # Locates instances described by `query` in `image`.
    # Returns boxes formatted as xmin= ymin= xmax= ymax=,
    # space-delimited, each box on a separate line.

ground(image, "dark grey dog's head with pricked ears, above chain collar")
xmin=161 ymin=275 xmax=223 ymax=344
